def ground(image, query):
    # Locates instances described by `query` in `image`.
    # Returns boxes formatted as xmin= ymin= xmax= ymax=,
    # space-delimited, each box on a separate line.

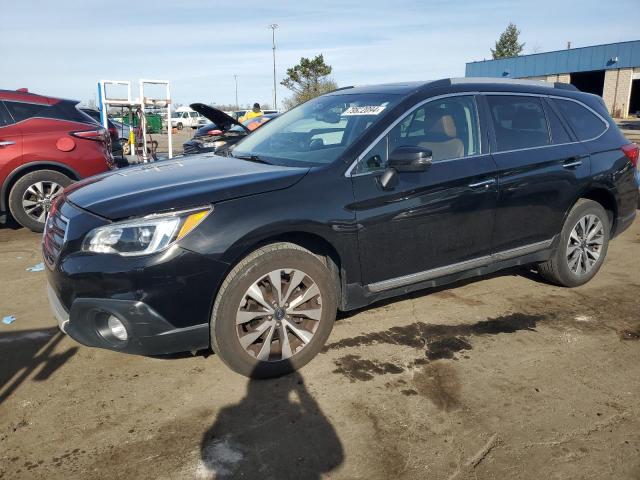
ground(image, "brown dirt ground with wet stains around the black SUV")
xmin=0 ymin=220 xmax=640 ymax=479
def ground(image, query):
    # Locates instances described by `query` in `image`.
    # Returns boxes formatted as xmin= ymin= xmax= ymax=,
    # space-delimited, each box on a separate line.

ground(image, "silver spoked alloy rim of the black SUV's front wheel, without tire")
xmin=236 ymin=269 xmax=322 ymax=362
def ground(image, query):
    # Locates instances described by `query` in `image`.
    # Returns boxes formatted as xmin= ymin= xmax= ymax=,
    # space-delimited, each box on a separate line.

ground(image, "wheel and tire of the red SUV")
xmin=9 ymin=170 xmax=73 ymax=232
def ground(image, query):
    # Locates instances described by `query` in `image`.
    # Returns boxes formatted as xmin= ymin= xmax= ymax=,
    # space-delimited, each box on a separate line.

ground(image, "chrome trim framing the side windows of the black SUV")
xmin=344 ymin=91 xmax=611 ymax=177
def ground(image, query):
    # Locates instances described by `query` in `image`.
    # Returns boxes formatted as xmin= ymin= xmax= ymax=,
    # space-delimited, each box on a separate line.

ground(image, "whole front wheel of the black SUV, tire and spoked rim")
xmin=211 ymin=243 xmax=337 ymax=378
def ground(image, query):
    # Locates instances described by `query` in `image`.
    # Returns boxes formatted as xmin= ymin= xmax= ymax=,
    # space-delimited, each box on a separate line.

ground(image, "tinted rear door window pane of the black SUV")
xmin=487 ymin=95 xmax=550 ymax=152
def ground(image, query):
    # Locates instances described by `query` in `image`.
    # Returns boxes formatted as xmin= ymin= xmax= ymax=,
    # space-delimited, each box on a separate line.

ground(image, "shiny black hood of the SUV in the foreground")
xmin=65 ymin=154 xmax=309 ymax=220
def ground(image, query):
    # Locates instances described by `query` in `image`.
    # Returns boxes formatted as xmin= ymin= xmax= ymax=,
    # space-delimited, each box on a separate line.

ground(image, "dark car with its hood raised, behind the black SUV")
xmin=182 ymin=103 xmax=276 ymax=155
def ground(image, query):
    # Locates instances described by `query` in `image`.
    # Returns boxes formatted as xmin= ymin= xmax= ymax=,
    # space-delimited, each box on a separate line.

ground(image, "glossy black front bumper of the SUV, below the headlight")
xmin=45 ymin=197 xmax=228 ymax=355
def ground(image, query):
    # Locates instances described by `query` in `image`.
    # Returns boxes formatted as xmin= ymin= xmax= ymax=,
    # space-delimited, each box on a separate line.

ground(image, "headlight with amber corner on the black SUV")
xmin=82 ymin=207 xmax=213 ymax=256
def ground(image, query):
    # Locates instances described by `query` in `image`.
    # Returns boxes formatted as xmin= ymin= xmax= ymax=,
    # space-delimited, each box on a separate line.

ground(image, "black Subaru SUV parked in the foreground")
xmin=43 ymin=79 xmax=638 ymax=377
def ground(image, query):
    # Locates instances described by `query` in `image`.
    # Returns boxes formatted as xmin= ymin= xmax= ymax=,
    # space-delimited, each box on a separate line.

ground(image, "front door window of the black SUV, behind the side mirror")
xmin=354 ymin=95 xmax=480 ymax=174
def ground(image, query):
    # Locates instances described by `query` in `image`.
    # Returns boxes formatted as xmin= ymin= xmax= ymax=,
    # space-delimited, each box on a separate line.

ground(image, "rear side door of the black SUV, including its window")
xmin=484 ymin=93 xmax=590 ymax=254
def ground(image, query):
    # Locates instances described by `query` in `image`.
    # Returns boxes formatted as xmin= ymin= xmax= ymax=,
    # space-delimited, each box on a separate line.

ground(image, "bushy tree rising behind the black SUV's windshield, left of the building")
xmin=280 ymin=54 xmax=338 ymax=108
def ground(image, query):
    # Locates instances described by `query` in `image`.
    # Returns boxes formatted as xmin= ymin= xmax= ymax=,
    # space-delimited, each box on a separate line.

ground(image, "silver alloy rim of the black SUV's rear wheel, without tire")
xmin=566 ymin=214 xmax=604 ymax=276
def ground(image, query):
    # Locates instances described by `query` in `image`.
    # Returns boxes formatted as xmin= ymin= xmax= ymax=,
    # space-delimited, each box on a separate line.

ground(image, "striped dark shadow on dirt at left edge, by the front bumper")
xmin=0 ymin=327 xmax=78 ymax=405
